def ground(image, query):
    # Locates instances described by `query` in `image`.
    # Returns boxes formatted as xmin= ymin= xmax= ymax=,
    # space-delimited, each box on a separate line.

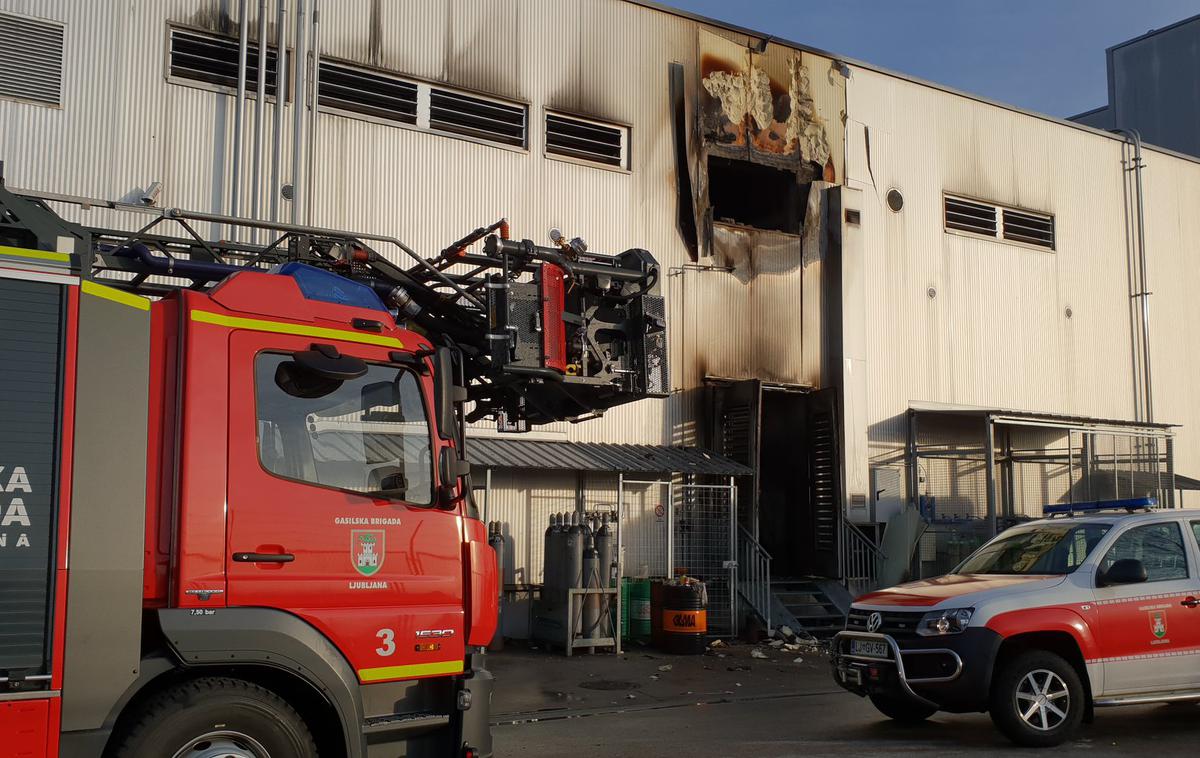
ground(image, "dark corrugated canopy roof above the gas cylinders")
xmin=467 ymin=437 xmax=752 ymax=476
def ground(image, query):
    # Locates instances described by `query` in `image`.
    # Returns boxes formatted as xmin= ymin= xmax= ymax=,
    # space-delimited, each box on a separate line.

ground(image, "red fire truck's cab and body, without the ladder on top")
xmin=0 ymin=200 xmax=498 ymax=758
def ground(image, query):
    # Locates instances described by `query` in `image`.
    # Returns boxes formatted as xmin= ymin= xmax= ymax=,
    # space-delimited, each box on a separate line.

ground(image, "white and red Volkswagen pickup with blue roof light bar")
xmin=833 ymin=499 xmax=1200 ymax=747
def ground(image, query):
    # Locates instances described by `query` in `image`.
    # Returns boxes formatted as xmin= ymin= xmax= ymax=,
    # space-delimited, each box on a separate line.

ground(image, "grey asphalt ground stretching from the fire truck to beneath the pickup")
xmin=490 ymin=645 xmax=1200 ymax=758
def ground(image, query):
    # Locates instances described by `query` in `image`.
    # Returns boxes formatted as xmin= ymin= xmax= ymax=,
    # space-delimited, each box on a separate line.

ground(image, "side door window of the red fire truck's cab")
xmin=254 ymin=353 xmax=433 ymax=505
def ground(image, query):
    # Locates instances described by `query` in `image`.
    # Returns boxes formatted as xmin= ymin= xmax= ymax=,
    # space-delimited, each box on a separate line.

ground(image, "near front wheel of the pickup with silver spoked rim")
xmin=991 ymin=650 xmax=1087 ymax=747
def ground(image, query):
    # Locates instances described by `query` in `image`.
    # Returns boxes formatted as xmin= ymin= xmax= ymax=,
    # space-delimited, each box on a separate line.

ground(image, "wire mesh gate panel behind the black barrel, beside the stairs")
xmin=672 ymin=485 xmax=737 ymax=636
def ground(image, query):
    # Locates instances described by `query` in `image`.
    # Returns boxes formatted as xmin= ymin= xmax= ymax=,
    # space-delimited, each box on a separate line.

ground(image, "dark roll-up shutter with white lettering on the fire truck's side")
xmin=0 ymin=277 xmax=64 ymax=688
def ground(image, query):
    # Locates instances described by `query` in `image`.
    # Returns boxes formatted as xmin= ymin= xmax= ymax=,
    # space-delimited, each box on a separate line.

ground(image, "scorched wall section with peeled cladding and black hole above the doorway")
xmin=684 ymin=29 xmax=846 ymax=387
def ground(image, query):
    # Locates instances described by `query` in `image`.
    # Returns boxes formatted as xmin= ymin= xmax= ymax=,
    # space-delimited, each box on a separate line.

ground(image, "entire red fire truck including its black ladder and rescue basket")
xmin=0 ymin=171 xmax=666 ymax=758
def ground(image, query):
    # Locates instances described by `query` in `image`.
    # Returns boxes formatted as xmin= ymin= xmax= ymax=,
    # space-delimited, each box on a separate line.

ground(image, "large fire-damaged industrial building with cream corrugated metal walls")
xmin=0 ymin=0 xmax=1200 ymax=634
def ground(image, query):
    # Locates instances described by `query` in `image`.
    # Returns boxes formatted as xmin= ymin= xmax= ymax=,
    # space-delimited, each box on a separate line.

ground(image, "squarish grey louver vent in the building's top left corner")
xmin=0 ymin=13 xmax=62 ymax=106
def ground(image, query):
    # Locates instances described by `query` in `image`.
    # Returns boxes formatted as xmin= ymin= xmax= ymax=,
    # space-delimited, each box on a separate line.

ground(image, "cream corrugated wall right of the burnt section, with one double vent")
xmin=847 ymin=68 xmax=1200 ymax=506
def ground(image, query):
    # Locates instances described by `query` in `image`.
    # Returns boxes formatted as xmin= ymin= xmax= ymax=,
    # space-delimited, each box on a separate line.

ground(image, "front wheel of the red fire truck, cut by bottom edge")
xmin=115 ymin=676 xmax=317 ymax=758
